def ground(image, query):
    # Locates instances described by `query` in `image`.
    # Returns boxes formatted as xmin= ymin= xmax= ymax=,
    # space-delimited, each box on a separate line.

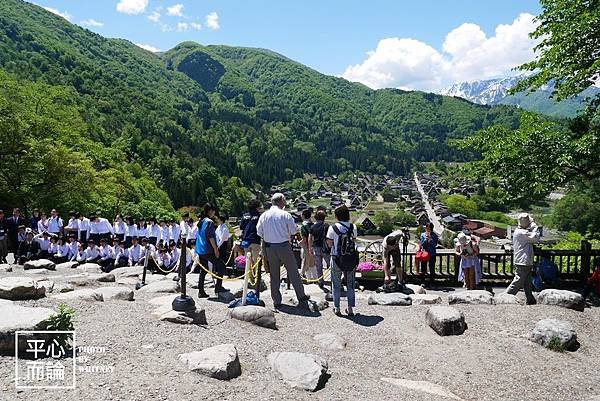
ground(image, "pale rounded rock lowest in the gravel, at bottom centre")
xmin=268 ymin=352 xmax=327 ymax=391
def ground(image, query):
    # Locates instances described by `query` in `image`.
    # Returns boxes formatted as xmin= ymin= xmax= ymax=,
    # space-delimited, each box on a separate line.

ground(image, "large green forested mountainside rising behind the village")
xmin=0 ymin=0 xmax=519 ymax=216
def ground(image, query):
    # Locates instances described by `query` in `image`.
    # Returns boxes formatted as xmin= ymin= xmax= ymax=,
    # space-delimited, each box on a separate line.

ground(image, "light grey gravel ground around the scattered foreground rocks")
xmin=0 ymin=270 xmax=600 ymax=401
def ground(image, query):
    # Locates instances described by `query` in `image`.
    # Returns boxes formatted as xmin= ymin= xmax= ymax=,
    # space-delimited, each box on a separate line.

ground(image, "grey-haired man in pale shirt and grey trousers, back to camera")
xmin=256 ymin=193 xmax=310 ymax=308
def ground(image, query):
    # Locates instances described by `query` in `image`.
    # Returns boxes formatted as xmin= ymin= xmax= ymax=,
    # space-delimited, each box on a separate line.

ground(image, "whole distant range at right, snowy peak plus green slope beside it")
xmin=441 ymin=76 xmax=600 ymax=118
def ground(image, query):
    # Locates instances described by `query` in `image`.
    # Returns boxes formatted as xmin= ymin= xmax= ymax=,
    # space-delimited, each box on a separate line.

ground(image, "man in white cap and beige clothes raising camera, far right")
xmin=506 ymin=213 xmax=540 ymax=305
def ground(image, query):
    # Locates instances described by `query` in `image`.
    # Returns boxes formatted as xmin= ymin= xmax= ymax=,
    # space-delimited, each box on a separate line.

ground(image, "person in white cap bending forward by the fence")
xmin=383 ymin=228 xmax=410 ymax=292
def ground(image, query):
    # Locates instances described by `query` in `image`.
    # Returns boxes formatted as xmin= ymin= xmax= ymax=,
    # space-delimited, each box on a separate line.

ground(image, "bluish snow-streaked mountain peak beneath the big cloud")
xmin=441 ymin=77 xmax=522 ymax=105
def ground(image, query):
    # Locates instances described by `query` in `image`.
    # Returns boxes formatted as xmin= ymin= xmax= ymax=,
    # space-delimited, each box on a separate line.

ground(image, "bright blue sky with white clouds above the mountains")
xmin=36 ymin=0 xmax=540 ymax=90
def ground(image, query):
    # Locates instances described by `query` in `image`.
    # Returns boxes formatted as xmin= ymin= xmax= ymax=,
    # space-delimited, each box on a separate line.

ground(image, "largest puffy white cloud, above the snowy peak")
xmin=342 ymin=13 xmax=537 ymax=91
